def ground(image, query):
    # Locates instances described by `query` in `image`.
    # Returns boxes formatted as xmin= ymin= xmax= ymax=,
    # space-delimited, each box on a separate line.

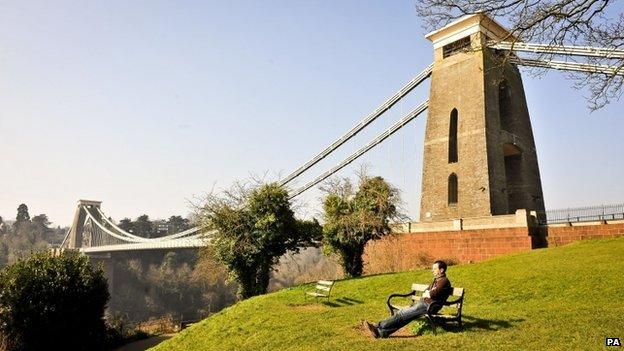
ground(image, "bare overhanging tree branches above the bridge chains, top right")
xmin=415 ymin=0 xmax=624 ymax=111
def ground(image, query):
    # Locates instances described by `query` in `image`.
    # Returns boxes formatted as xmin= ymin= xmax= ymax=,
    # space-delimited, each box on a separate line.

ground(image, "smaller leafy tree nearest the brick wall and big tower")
xmin=323 ymin=174 xmax=400 ymax=277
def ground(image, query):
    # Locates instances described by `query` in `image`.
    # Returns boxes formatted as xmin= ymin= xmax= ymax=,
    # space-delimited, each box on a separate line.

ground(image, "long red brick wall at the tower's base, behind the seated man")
xmin=364 ymin=228 xmax=531 ymax=274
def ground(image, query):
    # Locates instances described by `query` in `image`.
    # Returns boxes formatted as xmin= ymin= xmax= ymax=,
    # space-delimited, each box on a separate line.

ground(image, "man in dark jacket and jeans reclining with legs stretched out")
xmin=364 ymin=261 xmax=453 ymax=338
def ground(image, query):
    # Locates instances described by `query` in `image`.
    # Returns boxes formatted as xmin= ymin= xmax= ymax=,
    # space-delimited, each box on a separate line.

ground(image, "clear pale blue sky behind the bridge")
xmin=0 ymin=0 xmax=624 ymax=225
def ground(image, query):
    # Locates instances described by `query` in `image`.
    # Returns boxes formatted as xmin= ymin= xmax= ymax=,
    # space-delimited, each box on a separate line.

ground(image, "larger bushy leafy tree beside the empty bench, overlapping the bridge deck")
xmin=201 ymin=183 xmax=321 ymax=299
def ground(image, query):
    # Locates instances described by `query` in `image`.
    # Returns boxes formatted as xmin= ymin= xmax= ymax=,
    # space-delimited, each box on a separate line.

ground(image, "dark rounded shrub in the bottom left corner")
xmin=0 ymin=253 xmax=109 ymax=350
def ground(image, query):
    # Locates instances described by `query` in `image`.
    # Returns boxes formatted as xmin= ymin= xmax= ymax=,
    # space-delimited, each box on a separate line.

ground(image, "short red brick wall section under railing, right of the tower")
xmin=547 ymin=223 xmax=624 ymax=247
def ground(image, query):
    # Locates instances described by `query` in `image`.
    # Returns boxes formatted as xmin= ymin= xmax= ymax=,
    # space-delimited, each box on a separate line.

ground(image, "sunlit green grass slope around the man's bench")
xmin=155 ymin=238 xmax=624 ymax=351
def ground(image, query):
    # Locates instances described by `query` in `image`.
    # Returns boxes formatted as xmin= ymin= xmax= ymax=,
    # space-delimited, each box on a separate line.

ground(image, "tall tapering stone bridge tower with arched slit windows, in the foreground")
xmin=420 ymin=13 xmax=544 ymax=222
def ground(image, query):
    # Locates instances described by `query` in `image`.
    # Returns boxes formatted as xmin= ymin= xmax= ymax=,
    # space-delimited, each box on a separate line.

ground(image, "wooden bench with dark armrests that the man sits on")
xmin=387 ymin=284 xmax=464 ymax=332
